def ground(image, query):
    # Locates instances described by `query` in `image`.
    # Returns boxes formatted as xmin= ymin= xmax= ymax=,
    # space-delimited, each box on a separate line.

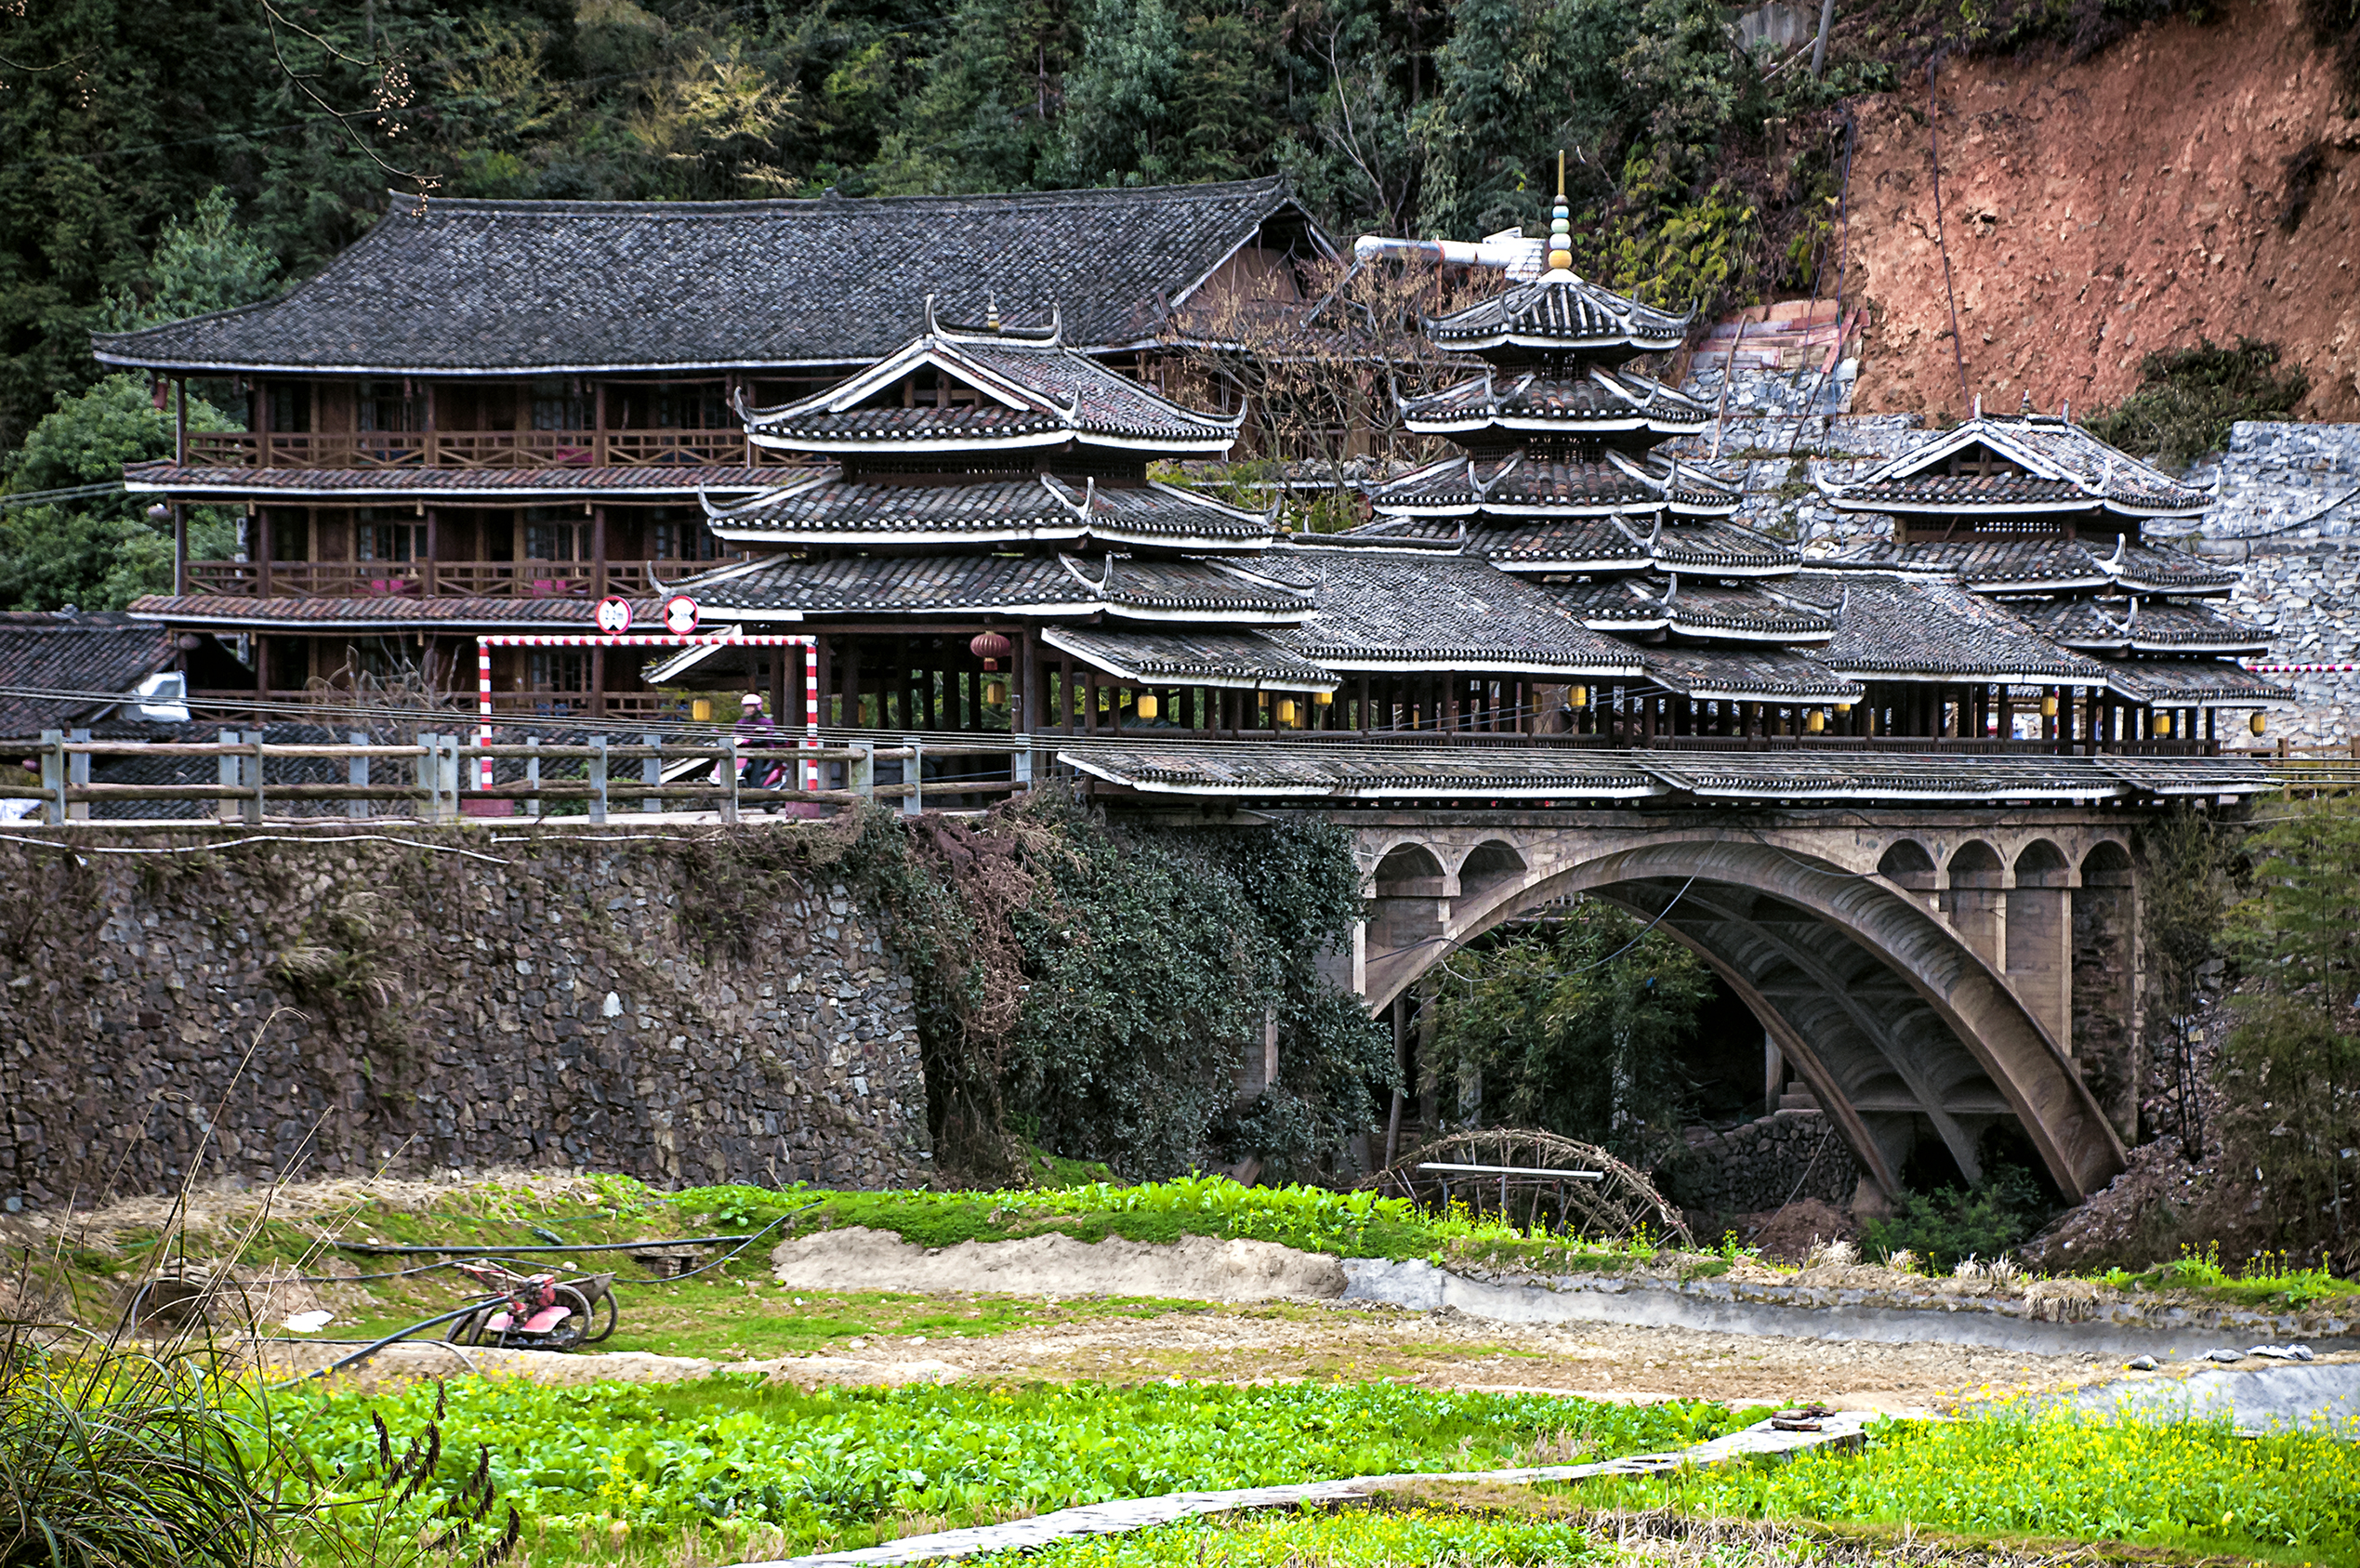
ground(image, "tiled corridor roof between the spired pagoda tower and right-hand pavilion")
xmin=1777 ymin=572 xmax=2105 ymax=685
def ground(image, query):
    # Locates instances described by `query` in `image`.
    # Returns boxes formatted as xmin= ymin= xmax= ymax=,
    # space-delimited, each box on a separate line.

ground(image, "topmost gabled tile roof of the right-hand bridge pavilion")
xmin=1831 ymin=414 xmax=2211 ymax=517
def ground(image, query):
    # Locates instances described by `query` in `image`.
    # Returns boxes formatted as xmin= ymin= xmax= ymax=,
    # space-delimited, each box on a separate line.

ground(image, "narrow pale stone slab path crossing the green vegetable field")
xmin=741 ymin=1410 xmax=1877 ymax=1568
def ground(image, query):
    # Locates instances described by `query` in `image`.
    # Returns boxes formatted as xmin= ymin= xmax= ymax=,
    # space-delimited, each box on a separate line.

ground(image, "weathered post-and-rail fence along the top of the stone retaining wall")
xmin=0 ymin=730 xmax=1036 ymax=826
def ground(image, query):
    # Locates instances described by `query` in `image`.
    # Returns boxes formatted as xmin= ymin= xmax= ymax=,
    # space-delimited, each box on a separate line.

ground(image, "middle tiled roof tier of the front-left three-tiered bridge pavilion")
xmin=713 ymin=470 xmax=1270 ymax=547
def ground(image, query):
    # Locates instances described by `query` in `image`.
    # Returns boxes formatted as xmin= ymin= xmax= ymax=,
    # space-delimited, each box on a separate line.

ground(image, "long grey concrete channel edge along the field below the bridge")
xmin=1343 ymin=1258 xmax=2360 ymax=1358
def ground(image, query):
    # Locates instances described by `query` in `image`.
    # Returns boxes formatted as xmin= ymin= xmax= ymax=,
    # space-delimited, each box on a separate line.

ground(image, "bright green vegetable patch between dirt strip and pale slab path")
xmin=276 ymin=1377 xmax=1748 ymax=1554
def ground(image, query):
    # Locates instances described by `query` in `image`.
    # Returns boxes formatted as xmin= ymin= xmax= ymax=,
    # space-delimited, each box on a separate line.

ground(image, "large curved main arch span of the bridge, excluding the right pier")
xmin=1362 ymin=829 xmax=2129 ymax=1197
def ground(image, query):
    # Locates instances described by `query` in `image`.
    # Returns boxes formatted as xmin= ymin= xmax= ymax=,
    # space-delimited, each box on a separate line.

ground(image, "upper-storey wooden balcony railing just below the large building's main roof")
xmin=189 ymin=429 xmax=785 ymax=470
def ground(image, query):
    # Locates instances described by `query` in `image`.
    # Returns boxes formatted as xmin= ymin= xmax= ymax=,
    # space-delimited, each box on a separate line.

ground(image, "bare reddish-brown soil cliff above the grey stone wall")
xmin=1851 ymin=0 xmax=2360 ymax=420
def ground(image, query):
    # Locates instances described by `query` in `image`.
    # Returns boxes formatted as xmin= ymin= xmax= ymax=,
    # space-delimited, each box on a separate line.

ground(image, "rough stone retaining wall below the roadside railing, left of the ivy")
xmin=0 ymin=826 xmax=928 ymax=1209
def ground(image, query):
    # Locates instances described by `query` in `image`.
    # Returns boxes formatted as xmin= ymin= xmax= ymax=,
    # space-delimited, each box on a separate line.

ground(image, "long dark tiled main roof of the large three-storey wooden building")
xmin=95 ymin=179 xmax=1326 ymax=373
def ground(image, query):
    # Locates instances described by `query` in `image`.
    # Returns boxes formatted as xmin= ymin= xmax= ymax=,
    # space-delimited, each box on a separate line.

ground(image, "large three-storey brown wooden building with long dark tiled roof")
xmin=95 ymin=179 xmax=1334 ymax=716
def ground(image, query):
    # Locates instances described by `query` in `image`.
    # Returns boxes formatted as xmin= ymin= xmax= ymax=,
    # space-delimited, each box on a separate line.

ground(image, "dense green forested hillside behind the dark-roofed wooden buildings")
xmin=18 ymin=0 xmax=2355 ymax=451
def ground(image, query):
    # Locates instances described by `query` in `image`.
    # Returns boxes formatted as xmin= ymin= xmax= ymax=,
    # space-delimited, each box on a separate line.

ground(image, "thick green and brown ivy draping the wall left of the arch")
xmin=678 ymin=794 xmax=1395 ymax=1180
